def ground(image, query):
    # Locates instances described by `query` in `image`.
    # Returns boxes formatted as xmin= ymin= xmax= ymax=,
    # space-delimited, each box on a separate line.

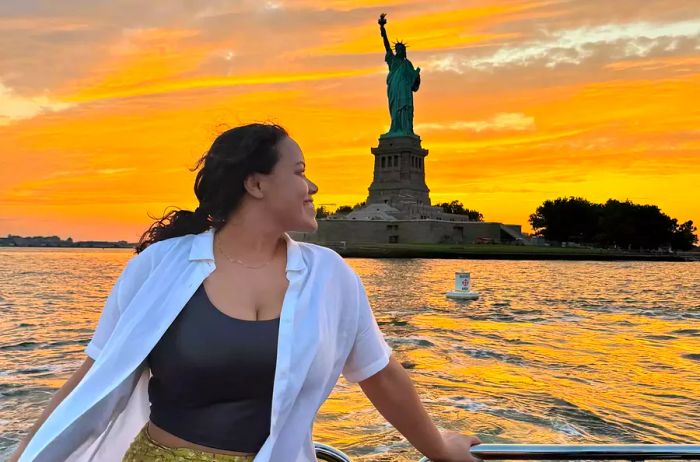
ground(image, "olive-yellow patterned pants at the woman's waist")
xmin=122 ymin=424 xmax=255 ymax=462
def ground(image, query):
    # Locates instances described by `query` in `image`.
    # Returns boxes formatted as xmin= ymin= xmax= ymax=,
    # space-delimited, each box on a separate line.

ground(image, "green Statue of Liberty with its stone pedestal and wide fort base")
xmin=290 ymin=14 xmax=524 ymax=244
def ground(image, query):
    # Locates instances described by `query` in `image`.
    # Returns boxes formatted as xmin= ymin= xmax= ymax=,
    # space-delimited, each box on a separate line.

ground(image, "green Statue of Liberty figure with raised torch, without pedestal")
xmin=378 ymin=13 xmax=420 ymax=138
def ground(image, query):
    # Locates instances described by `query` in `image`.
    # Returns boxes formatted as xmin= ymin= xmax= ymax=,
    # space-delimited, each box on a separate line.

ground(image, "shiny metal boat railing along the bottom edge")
xmin=314 ymin=443 xmax=700 ymax=462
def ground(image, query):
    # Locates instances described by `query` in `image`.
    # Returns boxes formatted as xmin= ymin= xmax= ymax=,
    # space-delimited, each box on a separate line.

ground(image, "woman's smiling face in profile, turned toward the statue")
xmin=265 ymin=137 xmax=318 ymax=232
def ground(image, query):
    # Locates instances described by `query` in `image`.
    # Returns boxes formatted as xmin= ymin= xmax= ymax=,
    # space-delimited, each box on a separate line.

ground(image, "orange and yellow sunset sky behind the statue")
xmin=0 ymin=0 xmax=700 ymax=242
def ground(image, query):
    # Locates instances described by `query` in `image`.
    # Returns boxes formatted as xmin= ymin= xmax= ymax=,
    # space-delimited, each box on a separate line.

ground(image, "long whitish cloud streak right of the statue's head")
xmin=425 ymin=19 xmax=700 ymax=74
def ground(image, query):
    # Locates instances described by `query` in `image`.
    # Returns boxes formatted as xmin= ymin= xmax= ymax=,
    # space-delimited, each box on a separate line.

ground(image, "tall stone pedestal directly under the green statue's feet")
xmin=367 ymin=135 xmax=430 ymax=207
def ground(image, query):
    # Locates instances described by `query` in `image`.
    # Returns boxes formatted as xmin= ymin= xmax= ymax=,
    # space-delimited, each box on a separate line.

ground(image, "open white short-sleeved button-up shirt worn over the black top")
xmin=20 ymin=228 xmax=391 ymax=462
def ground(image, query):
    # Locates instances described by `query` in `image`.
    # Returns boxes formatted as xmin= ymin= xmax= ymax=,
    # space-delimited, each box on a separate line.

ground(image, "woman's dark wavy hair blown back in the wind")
xmin=136 ymin=123 xmax=289 ymax=253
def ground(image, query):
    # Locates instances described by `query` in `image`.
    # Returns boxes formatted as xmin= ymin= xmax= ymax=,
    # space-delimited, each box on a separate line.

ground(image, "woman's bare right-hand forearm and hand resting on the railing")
xmin=360 ymin=356 xmax=481 ymax=462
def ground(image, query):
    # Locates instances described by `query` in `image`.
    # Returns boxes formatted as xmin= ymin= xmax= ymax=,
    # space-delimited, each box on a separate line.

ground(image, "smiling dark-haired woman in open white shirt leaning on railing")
xmin=11 ymin=124 xmax=480 ymax=462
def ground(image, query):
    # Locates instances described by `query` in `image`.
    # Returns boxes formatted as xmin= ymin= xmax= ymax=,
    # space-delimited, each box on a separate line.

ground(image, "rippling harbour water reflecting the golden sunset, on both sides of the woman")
xmin=0 ymin=248 xmax=700 ymax=461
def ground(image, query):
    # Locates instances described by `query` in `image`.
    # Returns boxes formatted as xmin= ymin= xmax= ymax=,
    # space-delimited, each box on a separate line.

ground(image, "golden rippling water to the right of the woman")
xmin=314 ymin=259 xmax=700 ymax=461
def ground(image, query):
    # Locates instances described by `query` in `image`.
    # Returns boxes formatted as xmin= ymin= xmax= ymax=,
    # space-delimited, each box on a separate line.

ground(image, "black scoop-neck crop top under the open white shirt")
xmin=148 ymin=284 xmax=279 ymax=453
